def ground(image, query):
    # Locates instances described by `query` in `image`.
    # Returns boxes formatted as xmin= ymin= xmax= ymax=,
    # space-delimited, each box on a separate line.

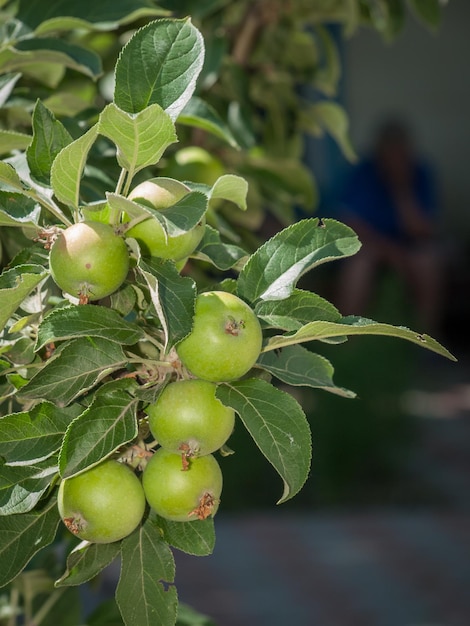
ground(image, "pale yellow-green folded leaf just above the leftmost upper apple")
xmin=51 ymin=124 xmax=98 ymax=208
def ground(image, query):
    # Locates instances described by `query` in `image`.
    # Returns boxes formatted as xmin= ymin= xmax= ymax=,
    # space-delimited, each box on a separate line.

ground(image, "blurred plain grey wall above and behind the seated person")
xmin=344 ymin=0 xmax=470 ymax=241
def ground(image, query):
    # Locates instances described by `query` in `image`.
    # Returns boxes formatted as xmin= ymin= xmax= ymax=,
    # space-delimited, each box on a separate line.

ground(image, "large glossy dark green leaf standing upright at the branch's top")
xmin=114 ymin=19 xmax=204 ymax=120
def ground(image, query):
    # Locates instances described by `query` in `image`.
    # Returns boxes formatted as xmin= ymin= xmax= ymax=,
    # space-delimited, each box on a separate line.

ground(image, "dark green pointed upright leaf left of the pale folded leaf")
xmin=26 ymin=100 xmax=72 ymax=186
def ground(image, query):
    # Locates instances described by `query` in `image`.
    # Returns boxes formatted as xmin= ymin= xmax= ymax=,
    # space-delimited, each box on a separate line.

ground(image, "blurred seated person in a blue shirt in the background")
xmin=337 ymin=120 xmax=442 ymax=335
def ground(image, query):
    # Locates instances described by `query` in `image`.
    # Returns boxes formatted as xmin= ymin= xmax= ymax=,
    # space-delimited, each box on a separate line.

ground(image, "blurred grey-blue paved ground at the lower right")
xmin=176 ymin=387 xmax=470 ymax=626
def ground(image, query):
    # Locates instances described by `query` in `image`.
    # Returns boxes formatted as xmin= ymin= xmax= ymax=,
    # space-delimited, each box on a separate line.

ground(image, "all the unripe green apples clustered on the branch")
xmin=50 ymin=179 xmax=262 ymax=543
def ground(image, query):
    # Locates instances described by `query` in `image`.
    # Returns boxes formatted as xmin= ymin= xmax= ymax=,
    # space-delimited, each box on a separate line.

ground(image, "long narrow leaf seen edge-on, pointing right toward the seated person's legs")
xmin=263 ymin=315 xmax=457 ymax=361
